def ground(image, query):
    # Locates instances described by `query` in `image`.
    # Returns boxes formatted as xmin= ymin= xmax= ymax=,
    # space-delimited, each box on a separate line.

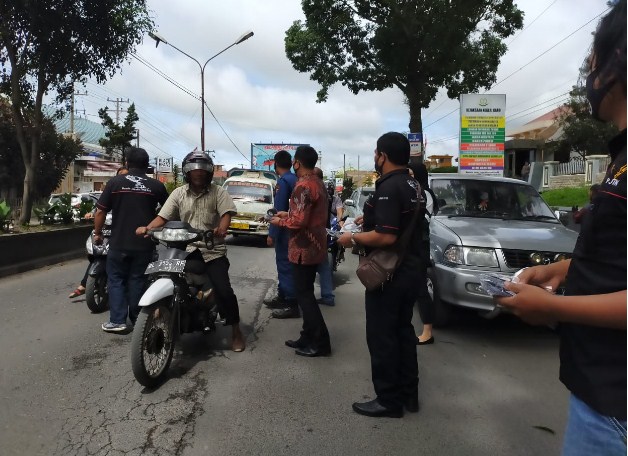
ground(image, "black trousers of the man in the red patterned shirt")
xmin=292 ymin=263 xmax=330 ymax=349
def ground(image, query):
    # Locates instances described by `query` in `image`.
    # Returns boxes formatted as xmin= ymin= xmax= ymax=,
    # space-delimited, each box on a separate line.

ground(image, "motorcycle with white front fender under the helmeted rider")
xmin=131 ymin=221 xmax=218 ymax=387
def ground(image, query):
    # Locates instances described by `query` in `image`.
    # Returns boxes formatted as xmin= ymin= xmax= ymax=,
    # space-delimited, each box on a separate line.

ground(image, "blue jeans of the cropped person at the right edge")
xmin=563 ymin=394 xmax=626 ymax=456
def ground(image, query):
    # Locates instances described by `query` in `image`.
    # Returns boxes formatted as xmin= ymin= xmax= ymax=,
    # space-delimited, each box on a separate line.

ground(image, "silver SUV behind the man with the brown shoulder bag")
xmin=427 ymin=174 xmax=578 ymax=325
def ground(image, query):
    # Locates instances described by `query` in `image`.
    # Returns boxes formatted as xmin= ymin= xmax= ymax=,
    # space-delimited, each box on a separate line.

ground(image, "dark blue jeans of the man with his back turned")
xmin=107 ymin=249 xmax=153 ymax=324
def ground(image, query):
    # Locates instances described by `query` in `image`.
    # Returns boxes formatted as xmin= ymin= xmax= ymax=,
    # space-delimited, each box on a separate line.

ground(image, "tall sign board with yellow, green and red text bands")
xmin=459 ymin=93 xmax=506 ymax=176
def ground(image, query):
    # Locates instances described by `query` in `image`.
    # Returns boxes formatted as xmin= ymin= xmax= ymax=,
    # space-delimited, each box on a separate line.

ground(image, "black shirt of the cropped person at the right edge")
xmin=560 ymin=126 xmax=626 ymax=420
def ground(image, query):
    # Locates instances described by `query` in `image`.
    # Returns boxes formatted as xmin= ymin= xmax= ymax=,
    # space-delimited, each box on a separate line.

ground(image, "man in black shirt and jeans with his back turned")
xmin=94 ymin=147 xmax=168 ymax=332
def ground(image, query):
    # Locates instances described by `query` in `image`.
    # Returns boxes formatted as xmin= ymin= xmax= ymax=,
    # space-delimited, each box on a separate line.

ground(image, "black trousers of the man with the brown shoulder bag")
xmin=365 ymin=269 xmax=425 ymax=408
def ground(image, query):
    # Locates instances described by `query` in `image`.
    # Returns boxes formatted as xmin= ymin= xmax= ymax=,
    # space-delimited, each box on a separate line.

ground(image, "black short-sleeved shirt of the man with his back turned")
xmin=96 ymin=169 xmax=168 ymax=250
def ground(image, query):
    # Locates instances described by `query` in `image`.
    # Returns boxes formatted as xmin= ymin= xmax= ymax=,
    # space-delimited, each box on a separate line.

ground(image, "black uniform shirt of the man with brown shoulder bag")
xmin=363 ymin=169 xmax=422 ymax=268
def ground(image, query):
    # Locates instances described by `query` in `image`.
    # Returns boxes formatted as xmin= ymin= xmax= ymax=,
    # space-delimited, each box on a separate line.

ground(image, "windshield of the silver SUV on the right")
xmin=431 ymin=179 xmax=558 ymax=223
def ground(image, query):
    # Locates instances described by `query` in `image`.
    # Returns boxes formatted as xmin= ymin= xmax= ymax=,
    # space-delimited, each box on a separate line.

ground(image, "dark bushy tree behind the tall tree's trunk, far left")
xmin=0 ymin=100 xmax=82 ymax=199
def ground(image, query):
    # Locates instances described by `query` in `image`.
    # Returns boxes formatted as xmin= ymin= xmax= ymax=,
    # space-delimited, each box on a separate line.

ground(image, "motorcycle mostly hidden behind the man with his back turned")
xmin=85 ymin=213 xmax=112 ymax=313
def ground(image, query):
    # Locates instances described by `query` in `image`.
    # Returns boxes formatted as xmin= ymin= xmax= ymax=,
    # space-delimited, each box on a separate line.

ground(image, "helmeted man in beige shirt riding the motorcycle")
xmin=136 ymin=151 xmax=245 ymax=352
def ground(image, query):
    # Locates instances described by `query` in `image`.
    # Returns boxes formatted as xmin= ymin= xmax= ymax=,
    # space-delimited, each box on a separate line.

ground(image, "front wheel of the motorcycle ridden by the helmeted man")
xmin=131 ymin=299 xmax=174 ymax=388
